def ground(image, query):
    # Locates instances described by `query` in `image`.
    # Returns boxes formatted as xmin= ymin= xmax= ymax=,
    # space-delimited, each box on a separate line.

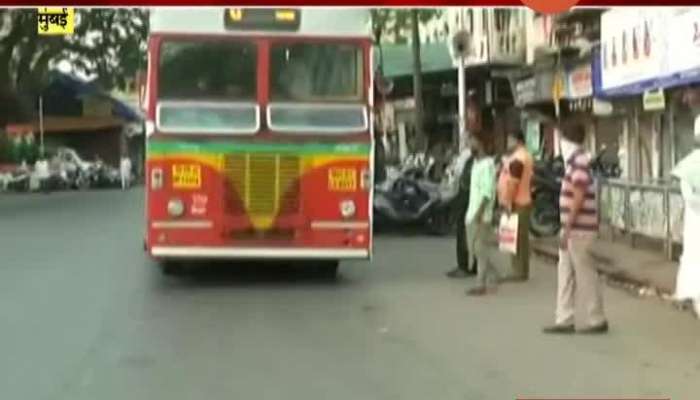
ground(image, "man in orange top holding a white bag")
xmin=498 ymin=130 xmax=534 ymax=282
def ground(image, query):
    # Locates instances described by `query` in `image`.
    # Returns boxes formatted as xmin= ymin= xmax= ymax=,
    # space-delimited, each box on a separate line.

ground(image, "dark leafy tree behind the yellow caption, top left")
xmin=0 ymin=8 xmax=148 ymax=123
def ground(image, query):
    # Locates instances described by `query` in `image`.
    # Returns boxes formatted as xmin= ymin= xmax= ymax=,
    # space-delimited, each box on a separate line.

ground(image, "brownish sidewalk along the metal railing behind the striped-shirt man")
xmin=531 ymin=234 xmax=678 ymax=295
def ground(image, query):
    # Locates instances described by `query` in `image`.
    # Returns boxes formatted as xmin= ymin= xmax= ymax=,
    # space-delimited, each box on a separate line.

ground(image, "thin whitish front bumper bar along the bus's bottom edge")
xmin=150 ymin=246 xmax=370 ymax=260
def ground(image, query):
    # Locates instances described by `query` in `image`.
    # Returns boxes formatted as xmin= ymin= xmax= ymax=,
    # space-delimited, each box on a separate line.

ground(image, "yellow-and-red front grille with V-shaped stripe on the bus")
xmin=224 ymin=153 xmax=302 ymax=222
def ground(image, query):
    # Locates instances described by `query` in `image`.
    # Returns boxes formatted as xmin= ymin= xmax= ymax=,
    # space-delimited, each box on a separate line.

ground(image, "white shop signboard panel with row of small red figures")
xmin=600 ymin=7 xmax=672 ymax=91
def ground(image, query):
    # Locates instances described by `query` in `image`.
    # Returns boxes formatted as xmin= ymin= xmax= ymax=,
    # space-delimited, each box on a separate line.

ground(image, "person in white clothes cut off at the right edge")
xmin=672 ymin=116 xmax=700 ymax=317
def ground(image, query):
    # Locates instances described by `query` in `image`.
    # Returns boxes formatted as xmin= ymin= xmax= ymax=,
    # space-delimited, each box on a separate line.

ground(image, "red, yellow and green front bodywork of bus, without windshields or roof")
xmin=145 ymin=10 xmax=373 ymax=261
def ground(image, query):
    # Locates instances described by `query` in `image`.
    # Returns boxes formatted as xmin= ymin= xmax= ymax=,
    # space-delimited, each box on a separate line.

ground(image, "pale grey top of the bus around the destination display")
xmin=150 ymin=7 xmax=371 ymax=37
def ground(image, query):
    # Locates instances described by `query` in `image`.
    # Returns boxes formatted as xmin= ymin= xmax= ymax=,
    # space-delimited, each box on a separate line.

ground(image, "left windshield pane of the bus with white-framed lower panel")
xmin=157 ymin=40 xmax=259 ymax=134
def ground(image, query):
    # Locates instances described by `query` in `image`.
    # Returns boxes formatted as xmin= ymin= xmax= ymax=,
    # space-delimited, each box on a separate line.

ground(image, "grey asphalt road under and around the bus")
xmin=0 ymin=189 xmax=700 ymax=400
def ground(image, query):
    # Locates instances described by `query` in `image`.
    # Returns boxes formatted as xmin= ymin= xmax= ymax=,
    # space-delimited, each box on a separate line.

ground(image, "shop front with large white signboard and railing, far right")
xmin=594 ymin=8 xmax=700 ymax=256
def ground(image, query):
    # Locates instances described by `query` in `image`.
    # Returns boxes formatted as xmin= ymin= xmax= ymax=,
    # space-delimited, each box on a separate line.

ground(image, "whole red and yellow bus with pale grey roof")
xmin=145 ymin=8 xmax=374 ymax=274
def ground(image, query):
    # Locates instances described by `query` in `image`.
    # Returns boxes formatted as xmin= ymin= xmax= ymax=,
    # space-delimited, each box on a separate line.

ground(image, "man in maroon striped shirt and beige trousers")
xmin=544 ymin=125 xmax=608 ymax=333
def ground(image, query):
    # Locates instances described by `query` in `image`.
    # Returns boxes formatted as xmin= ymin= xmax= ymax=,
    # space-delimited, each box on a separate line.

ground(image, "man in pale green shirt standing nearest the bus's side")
xmin=466 ymin=137 xmax=499 ymax=296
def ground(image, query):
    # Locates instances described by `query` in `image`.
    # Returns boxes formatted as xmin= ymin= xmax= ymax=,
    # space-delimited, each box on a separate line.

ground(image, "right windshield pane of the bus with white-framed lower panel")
xmin=268 ymin=43 xmax=367 ymax=133
